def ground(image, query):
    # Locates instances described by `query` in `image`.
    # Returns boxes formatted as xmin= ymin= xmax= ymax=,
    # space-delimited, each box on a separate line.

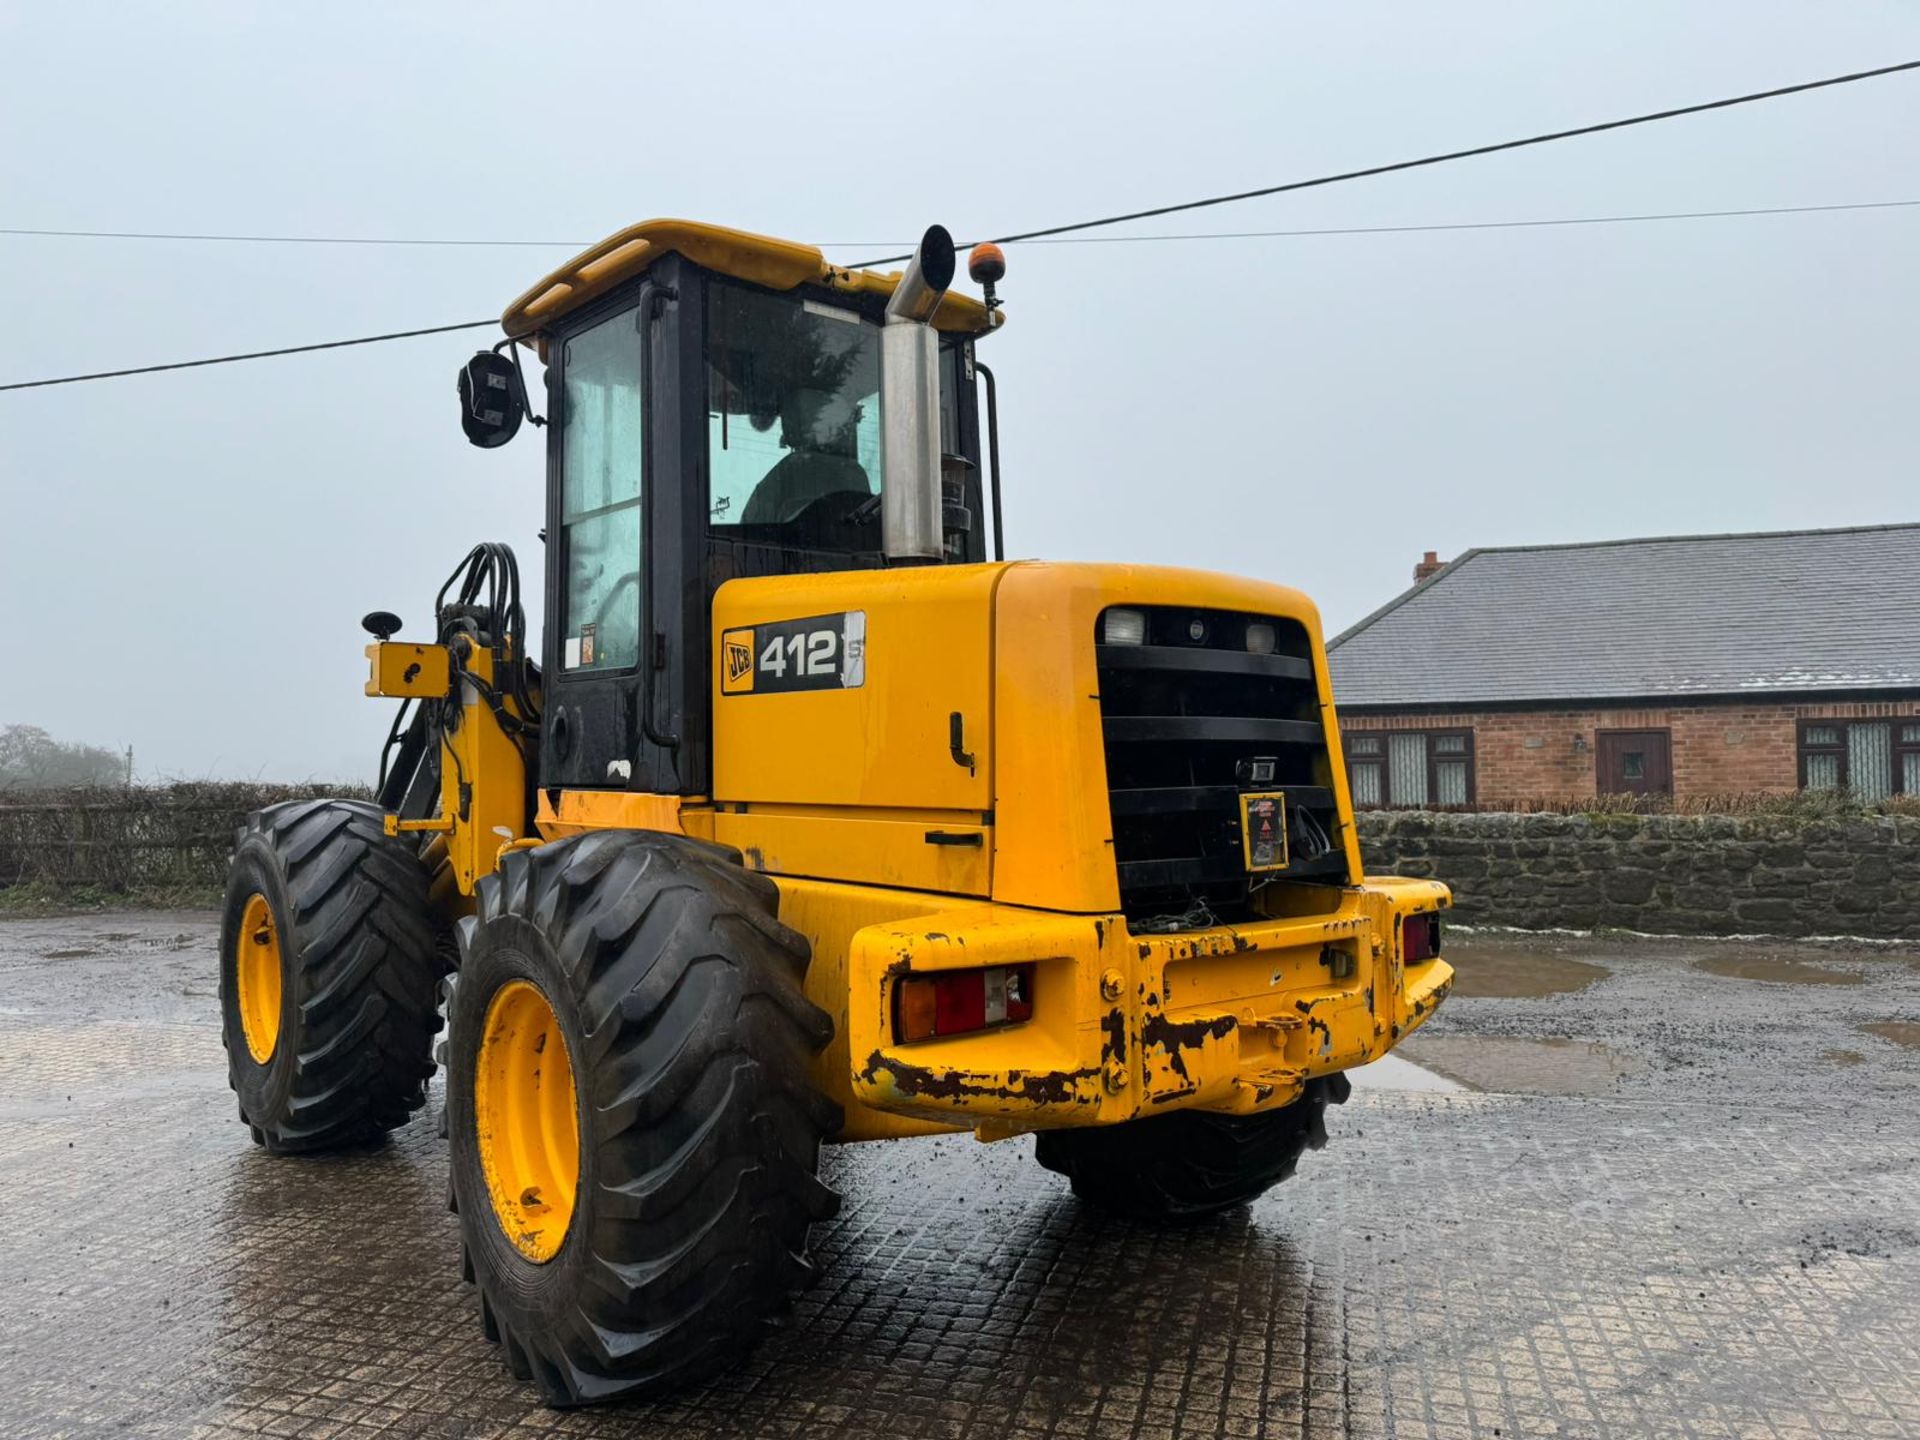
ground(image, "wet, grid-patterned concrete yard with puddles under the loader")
xmin=0 ymin=916 xmax=1920 ymax=1440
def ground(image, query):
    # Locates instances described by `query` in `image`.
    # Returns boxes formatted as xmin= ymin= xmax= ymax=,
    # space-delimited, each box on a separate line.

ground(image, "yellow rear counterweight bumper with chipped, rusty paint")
xmin=847 ymin=879 xmax=1453 ymax=1135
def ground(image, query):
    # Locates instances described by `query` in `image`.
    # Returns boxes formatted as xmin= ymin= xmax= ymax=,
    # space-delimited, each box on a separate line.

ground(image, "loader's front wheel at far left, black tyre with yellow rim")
xmin=221 ymin=801 xmax=445 ymax=1154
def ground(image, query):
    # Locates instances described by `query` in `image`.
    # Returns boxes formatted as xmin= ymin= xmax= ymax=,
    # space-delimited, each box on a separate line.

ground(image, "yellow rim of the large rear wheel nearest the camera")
xmin=474 ymin=979 xmax=580 ymax=1265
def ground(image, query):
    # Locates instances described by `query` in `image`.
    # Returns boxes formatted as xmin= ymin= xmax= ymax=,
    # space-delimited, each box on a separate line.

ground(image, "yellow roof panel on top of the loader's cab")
xmin=499 ymin=221 xmax=1004 ymax=340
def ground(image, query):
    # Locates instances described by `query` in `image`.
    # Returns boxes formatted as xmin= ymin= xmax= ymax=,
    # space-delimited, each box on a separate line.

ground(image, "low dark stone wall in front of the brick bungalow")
xmin=1359 ymin=810 xmax=1920 ymax=939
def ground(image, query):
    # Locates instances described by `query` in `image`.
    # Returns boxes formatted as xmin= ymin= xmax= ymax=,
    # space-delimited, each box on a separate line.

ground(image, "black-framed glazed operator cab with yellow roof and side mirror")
xmin=461 ymin=221 xmax=1004 ymax=795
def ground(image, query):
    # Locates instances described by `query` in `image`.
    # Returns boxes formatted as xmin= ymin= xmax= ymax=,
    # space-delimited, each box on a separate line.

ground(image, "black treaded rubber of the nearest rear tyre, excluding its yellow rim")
xmin=455 ymin=831 xmax=841 ymax=1405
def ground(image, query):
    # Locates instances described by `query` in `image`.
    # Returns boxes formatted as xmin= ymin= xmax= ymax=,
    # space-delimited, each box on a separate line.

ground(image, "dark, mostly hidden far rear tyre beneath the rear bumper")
xmin=1033 ymin=1075 xmax=1352 ymax=1221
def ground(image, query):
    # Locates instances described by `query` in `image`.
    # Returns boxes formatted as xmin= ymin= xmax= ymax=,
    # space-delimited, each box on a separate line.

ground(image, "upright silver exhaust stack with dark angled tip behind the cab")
xmin=879 ymin=225 xmax=954 ymax=563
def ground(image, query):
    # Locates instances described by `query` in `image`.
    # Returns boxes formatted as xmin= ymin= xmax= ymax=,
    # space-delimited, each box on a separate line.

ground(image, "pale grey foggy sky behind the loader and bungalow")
xmin=0 ymin=0 xmax=1920 ymax=780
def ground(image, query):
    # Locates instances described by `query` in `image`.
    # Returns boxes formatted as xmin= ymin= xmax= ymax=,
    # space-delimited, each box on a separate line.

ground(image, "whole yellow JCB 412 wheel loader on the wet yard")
xmin=221 ymin=221 xmax=1452 ymax=1405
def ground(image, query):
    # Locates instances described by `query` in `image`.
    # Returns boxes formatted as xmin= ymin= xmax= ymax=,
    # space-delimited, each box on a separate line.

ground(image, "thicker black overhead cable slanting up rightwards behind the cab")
xmin=0 ymin=60 xmax=1920 ymax=392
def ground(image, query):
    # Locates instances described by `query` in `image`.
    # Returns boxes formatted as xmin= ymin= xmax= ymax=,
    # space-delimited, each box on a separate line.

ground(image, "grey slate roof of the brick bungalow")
xmin=1327 ymin=524 xmax=1920 ymax=707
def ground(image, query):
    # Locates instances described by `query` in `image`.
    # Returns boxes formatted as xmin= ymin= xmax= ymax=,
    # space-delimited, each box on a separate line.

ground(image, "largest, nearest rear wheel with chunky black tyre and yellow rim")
xmin=447 ymin=831 xmax=841 ymax=1407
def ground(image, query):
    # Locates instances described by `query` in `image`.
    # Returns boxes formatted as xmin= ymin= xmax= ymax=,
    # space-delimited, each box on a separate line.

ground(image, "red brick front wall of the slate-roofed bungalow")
xmin=1340 ymin=697 xmax=1920 ymax=806
